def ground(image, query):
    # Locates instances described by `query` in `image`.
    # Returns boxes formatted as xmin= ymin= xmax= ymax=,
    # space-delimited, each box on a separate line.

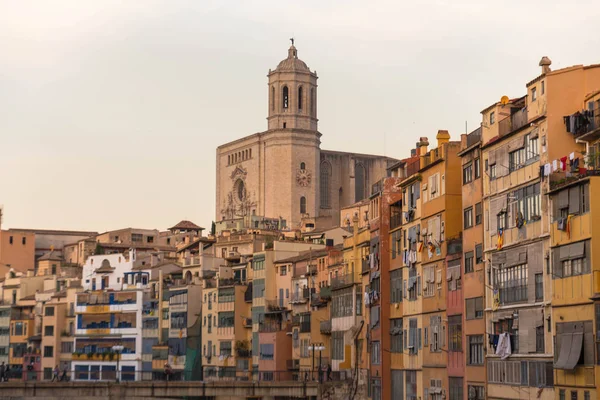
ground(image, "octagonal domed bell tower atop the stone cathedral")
xmin=267 ymin=39 xmax=318 ymax=132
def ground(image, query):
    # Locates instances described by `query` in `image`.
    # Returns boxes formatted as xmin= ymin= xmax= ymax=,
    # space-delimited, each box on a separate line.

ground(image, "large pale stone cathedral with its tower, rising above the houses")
xmin=216 ymin=42 xmax=397 ymax=228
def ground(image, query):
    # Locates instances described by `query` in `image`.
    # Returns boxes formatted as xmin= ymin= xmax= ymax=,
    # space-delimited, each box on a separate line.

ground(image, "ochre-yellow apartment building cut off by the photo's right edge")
xmin=548 ymin=92 xmax=600 ymax=399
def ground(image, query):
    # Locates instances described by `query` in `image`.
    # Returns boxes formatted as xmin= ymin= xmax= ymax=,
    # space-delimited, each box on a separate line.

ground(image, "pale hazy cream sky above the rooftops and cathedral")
xmin=0 ymin=0 xmax=600 ymax=231
